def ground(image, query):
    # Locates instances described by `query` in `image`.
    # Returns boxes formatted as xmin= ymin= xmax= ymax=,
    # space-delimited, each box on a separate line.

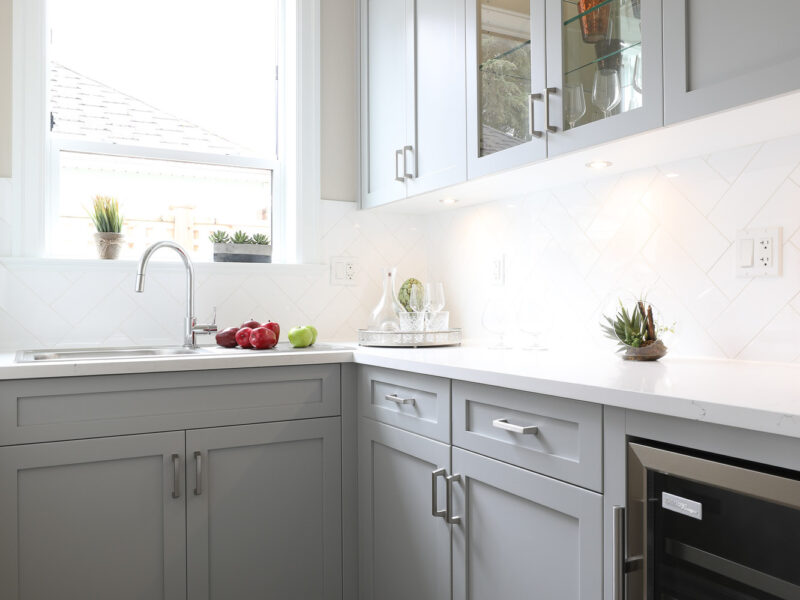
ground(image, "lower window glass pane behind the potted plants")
xmin=51 ymin=152 xmax=272 ymax=261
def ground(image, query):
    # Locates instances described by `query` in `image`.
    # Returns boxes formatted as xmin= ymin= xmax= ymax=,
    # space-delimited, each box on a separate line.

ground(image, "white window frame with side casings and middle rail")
xmin=10 ymin=0 xmax=321 ymax=266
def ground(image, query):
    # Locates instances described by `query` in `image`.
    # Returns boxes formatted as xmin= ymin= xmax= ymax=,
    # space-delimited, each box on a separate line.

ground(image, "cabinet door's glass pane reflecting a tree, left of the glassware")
xmin=478 ymin=0 xmax=532 ymax=156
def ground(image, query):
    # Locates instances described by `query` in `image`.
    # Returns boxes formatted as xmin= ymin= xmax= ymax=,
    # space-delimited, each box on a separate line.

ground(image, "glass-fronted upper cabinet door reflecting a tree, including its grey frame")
xmin=466 ymin=0 xmax=547 ymax=179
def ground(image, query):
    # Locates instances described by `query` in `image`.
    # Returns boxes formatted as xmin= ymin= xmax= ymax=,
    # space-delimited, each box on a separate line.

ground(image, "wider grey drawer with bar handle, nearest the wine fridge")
xmin=453 ymin=381 xmax=603 ymax=491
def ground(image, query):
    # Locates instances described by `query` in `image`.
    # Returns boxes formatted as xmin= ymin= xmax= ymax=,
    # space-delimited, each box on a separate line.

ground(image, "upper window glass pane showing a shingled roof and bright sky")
xmin=48 ymin=0 xmax=278 ymax=158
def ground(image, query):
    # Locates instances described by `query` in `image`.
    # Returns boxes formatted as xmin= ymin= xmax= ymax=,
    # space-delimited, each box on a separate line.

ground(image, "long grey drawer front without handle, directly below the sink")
xmin=0 ymin=364 xmax=341 ymax=446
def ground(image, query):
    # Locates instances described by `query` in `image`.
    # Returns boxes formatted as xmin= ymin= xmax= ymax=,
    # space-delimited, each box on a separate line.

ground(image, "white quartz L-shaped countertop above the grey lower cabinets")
xmin=0 ymin=343 xmax=800 ymax=437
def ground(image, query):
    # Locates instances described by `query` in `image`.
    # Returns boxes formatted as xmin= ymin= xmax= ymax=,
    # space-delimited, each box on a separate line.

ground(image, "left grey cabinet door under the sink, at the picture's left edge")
xmin=0 ymin=432 xmax=186 ymax=600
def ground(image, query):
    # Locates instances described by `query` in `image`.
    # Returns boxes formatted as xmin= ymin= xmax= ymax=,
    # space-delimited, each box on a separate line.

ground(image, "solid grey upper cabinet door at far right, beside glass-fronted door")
xmin=664 ymin=0 xmax=800 ymax=124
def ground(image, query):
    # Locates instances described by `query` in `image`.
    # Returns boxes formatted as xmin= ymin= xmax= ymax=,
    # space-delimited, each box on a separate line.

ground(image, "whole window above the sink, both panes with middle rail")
xmin=46 ymin=0 xmax=282 ymax=260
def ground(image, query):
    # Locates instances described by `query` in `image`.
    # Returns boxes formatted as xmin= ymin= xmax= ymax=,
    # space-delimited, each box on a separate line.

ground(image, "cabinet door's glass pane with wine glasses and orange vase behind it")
xmin=561 ymin=0 xmax=643 ymax=129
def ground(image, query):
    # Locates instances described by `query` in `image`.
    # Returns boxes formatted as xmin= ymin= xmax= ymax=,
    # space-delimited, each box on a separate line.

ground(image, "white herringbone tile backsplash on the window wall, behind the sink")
xmin=0 ymin=201 xmax=426 ymax=351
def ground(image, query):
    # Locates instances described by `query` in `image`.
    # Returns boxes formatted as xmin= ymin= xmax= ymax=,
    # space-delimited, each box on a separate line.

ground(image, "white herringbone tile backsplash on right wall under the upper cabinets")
xmin=428 ymin=137 xmax=800 ymax=362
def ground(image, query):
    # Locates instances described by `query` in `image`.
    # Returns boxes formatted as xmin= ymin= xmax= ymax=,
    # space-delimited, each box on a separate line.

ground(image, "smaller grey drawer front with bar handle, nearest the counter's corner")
xmin=358 ymin=367 xmax=450 ymax=444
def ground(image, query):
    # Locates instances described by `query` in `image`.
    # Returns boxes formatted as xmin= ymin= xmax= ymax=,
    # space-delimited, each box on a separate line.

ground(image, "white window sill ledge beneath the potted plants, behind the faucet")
xmin=0 ymin=254 xmax=328 ymax=275
